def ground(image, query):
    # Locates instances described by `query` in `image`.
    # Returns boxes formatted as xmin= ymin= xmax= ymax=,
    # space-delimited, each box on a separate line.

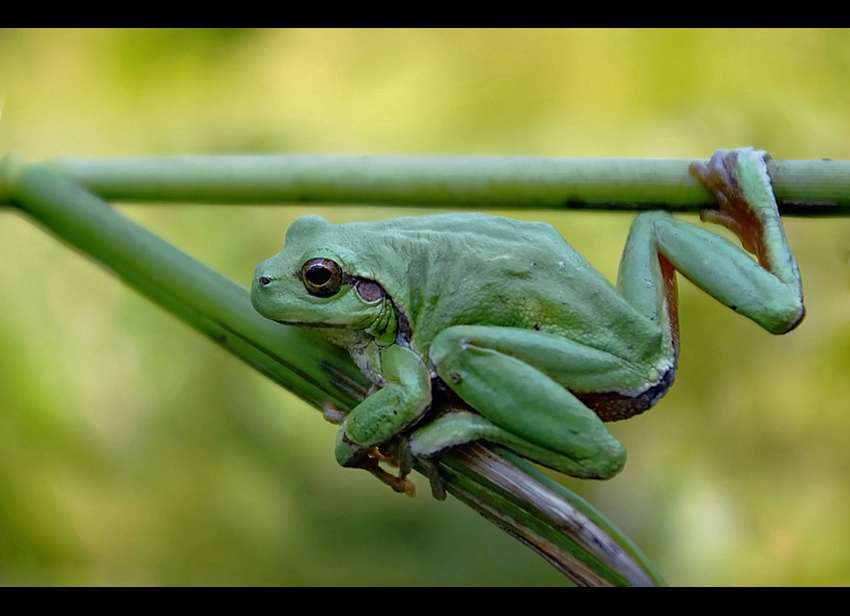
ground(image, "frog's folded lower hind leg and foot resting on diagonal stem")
xmin=418 ymin=326 xmax=625 ymax=478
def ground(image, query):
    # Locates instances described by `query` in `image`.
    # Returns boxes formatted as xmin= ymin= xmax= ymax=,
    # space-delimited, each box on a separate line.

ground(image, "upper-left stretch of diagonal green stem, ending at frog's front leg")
xmin=0 ymin=156 xmax=367 ymax=407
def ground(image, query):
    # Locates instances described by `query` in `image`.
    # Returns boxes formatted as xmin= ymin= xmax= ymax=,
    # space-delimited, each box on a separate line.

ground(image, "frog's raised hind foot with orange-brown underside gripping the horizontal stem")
xmin=689 ymin=148 xmax=779 ymax=269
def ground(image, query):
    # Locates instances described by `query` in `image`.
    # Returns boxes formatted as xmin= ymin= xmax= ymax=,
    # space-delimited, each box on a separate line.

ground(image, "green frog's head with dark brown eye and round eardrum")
xmin=251 ymin=216 xmax=396 ymax=337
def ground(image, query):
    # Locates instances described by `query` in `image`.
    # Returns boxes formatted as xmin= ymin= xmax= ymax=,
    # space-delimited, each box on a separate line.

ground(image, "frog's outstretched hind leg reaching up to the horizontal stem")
xmin=617 ymin=148 xmax=805 ymax=339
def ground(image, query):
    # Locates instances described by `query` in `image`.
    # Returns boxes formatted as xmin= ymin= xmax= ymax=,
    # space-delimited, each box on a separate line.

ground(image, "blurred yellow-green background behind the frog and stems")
xmin=0 ymin=30 xmax=850 ymax=585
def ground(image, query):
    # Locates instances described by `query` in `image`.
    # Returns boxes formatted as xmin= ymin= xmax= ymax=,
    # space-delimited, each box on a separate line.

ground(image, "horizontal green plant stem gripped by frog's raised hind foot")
xmin=38 ymin=154 xmax=850 ymax=216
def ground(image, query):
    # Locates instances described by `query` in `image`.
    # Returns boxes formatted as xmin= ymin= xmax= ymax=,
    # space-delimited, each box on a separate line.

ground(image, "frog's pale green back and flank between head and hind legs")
xmin=332 ymin=214 xmax=638 ymax=351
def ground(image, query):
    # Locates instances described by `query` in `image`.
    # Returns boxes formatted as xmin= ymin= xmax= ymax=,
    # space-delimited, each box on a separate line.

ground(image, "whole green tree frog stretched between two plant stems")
xmin=251 ymin=148 xmax=805 ymax=495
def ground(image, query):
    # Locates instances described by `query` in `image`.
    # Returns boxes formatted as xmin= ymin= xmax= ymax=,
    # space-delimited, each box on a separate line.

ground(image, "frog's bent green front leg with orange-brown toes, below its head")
xmin=334 ymin=345 xmax=431 ymax=495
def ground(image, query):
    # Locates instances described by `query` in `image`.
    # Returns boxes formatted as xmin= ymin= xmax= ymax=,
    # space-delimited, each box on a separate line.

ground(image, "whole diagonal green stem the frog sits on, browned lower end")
xmin=0 ymin=155 xmax=664 ymax=586
